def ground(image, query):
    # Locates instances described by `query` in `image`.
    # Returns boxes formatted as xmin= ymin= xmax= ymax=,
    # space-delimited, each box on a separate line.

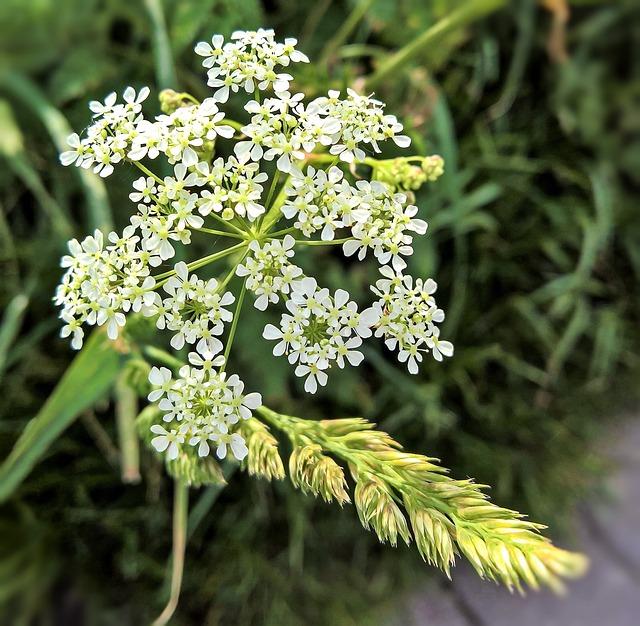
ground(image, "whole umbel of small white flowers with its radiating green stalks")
xmin=55 ymin=30 xmax=453 ymax=459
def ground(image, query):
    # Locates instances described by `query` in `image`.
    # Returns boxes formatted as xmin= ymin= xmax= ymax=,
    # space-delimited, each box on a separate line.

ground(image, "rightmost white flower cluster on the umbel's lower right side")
xmin=371 ymin=266 xmax=453 ymax=374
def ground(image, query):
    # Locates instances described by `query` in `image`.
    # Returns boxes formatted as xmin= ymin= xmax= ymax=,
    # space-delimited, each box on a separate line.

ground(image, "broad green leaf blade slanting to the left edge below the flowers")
xmin=0 ymin=332 xmax=121 ymax=503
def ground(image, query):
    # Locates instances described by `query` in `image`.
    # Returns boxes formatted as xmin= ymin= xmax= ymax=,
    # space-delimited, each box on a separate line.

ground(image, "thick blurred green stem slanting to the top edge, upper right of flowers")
xmin=364 ymin=0 xmax=506 ymax=91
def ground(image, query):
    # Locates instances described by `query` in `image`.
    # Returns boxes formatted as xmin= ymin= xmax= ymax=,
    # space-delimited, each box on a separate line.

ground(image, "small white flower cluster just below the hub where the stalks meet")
xmin=236 ymin=235 xmax=302 ymax=311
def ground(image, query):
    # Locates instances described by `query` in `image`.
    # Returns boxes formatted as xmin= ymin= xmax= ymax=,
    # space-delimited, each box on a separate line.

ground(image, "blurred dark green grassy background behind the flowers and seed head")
xmin=0 ymin=0 xmax=640 ymax=625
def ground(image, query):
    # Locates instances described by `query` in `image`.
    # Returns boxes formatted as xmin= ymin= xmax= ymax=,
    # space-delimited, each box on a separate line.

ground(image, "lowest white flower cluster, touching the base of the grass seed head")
xmin=149 ymin=350 xmax=262 ymax=460
